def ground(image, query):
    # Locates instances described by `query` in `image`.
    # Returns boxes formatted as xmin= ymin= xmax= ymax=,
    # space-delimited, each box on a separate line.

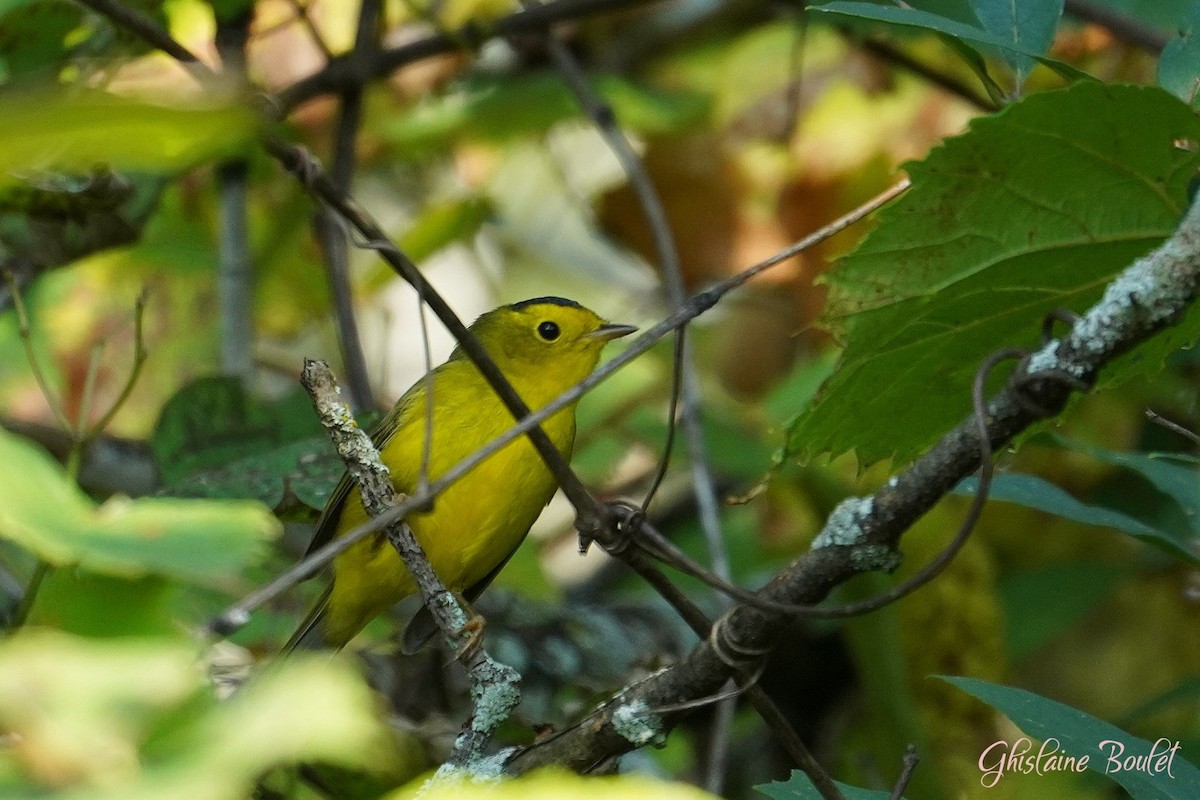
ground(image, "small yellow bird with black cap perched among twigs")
xmin=284 ymin=297 xmax=636 ymax=651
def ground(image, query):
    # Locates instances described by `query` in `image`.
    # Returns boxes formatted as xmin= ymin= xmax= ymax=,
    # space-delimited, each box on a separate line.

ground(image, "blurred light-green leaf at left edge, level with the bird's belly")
xmin=0 ymin=431 xmax=278 ymax=582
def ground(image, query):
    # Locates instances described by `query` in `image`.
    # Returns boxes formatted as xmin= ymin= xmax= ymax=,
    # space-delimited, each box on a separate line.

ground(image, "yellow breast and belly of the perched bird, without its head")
xmin=325 ymin=360 xmax=575 ymax=642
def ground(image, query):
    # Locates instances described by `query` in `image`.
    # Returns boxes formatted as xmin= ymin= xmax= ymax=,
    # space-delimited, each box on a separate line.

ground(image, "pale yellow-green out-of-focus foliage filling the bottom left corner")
xmin=0 ymin=630 xmax=385 ymax=800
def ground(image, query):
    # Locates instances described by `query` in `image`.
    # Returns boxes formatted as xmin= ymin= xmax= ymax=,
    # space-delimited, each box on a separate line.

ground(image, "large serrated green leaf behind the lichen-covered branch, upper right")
xmin=788 ymin=83 xmax=1200 ymax=464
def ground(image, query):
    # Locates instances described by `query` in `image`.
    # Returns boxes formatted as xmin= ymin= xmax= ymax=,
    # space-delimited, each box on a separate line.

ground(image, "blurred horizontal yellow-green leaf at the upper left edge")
xmin=0 ymin=89 xmax=257 ymax=175
